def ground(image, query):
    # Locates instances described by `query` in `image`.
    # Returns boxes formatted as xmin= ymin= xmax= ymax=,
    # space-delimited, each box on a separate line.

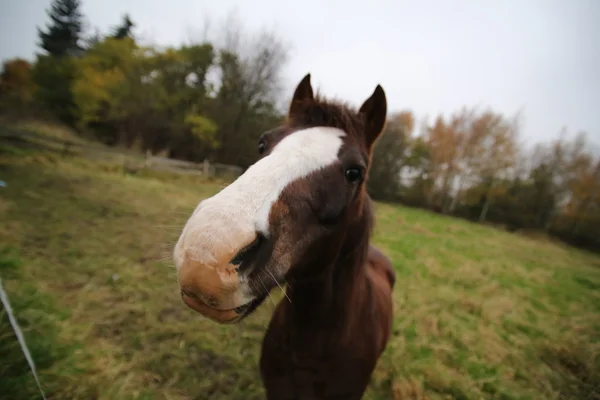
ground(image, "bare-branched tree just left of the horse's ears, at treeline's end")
xmin=204 ymin=14 xmax=288 ymax=166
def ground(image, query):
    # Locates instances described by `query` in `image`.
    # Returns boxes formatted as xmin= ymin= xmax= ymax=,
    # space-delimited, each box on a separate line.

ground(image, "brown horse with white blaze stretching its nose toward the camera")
xmin=173 ymin=74 xmax=396 ymax=400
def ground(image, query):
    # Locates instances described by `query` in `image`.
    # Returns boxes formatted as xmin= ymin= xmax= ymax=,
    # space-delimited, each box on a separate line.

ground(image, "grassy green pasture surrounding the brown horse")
xmin=0 ymin=136 xmax=600 ymax=400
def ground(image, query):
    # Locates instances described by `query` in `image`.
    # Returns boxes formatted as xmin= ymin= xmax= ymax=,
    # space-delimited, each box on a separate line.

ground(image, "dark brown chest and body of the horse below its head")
xmin=260 ymin=247 xmax=394 ymax=400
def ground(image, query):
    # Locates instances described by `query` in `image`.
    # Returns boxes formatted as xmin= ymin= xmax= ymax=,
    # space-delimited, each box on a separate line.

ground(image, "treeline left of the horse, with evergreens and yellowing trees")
xmin=0 ymin=0 xmax=287 ymax=167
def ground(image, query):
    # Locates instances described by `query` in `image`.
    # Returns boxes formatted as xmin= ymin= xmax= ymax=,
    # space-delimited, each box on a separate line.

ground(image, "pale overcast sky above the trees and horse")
xmin=0 ymin=0 xmax=600 ymax=148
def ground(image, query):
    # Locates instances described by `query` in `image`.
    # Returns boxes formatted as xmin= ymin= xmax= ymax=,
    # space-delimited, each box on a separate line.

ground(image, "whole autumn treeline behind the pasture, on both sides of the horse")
xmin=0 ymin=0 xmax=600 ymax=250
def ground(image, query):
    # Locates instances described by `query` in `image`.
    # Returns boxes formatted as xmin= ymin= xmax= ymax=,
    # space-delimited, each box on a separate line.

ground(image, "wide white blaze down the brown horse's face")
xmin=174 ymin=127 xmax=345 ymax=268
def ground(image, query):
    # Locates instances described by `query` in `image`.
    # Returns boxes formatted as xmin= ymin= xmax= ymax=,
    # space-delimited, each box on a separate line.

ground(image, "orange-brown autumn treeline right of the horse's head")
xmin=368 ymin=108 xmax=600 ymax=251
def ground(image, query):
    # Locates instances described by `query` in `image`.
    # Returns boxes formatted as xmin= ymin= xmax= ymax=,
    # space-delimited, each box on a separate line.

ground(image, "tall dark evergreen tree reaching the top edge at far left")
xmin=38 ymin=0 xmax=83 ymax=57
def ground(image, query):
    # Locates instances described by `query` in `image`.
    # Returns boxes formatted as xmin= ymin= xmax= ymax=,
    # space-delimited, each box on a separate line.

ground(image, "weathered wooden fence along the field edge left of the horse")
xmin=0 ymin=127 xmax=243 ymax=179
